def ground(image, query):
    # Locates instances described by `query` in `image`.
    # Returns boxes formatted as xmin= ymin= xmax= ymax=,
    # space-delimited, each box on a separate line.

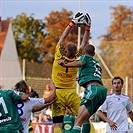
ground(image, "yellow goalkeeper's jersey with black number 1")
xmin=52 ymin=45 xmax=82 ymax=89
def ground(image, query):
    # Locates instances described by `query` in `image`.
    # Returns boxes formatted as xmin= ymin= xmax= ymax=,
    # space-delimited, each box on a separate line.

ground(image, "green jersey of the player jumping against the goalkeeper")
xmin=77 ymin=55 xmax=102 ymax=86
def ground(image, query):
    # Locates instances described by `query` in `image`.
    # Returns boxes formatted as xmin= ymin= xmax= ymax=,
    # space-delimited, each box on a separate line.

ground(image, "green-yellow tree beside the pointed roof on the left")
xmin=12 ymin=13 xmax=45 ymax=62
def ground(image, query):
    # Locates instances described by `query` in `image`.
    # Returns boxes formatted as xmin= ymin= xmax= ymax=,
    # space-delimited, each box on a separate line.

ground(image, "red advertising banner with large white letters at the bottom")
xmin=32 ymin=123 xmax=53 ymax=133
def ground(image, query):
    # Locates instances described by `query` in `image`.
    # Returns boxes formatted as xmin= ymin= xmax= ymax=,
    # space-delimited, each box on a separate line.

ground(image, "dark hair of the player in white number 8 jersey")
xmin=14 ymin=80 xmax=28 ymax=93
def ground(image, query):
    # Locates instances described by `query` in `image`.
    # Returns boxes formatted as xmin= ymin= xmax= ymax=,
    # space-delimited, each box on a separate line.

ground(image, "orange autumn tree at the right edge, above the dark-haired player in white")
xmin=99 ymin=5 xmax=133 ymax=78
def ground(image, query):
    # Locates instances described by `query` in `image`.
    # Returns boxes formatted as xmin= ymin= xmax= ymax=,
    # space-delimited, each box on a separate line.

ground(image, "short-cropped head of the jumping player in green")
xmin=84 ymin=44 xmax=95 ymax=56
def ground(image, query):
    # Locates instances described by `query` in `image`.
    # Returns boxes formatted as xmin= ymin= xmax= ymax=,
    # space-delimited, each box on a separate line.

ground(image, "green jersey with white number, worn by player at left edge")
xmin=0 ymin=90 xmax=23 ymax=130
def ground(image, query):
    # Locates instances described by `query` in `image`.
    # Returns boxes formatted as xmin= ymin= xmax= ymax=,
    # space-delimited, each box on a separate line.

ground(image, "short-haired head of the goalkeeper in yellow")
xmin=64 ymin=42 xmax=77 ymax=58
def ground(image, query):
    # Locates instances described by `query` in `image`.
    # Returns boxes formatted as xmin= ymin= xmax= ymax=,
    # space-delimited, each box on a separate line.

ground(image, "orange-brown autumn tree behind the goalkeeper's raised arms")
xmin=42 ymin=8 xmax=78 ymax=62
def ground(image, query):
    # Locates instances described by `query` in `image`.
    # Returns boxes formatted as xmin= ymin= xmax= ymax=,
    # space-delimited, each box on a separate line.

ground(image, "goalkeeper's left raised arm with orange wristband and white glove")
xmin=57 ymin=12 xmax=84 ymax=45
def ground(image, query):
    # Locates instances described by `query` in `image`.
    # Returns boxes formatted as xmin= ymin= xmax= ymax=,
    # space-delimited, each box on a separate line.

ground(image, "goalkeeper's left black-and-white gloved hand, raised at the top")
xmin=72 ymin=12 xmax=84 ymax=25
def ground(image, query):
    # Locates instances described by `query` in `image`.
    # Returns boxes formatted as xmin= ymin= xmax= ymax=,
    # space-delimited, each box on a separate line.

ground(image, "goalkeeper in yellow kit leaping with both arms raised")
xmin=52 ymin=12 xmax=91 ymax=133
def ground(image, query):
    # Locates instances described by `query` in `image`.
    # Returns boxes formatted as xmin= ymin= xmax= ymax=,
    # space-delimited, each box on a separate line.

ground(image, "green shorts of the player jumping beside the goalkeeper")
xmin=80 ymin=85 xmax=108 ymax=114
